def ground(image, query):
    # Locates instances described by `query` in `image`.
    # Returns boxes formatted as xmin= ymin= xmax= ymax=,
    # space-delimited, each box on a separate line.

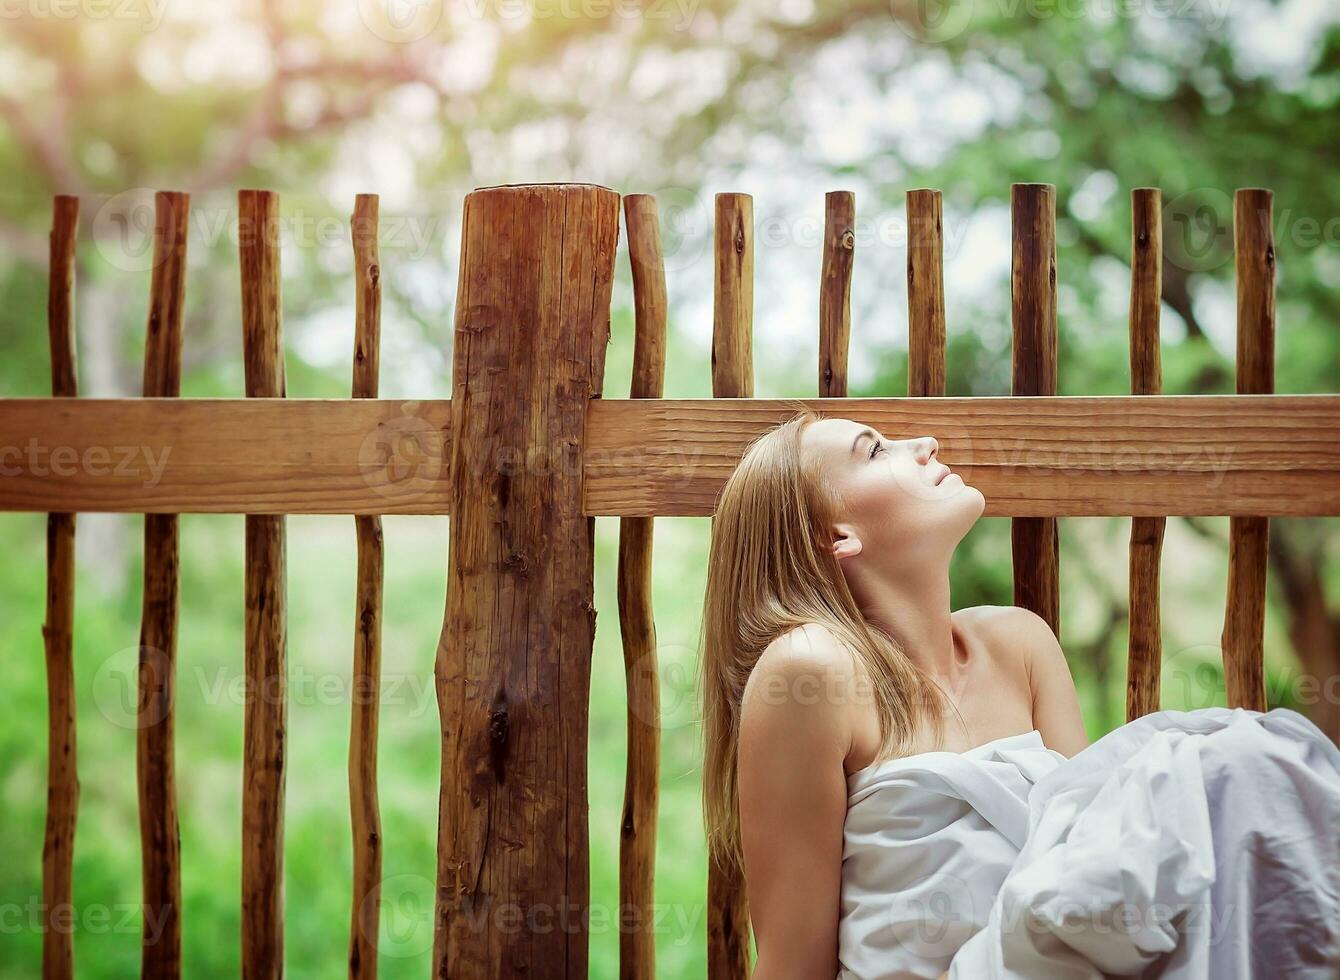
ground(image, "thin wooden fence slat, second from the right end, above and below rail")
xmin=1126 ymin=188 xmax=1167 ymax=721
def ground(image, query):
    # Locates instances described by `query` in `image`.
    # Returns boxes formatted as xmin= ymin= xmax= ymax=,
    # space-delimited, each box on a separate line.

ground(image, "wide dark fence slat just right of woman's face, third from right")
xmin=1010 ymin=184 xmax=1061 ymax=637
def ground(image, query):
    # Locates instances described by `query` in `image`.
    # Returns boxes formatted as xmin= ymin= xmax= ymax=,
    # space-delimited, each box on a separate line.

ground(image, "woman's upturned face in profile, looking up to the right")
xmin=803 ymin=418 xmax=986 ymax=563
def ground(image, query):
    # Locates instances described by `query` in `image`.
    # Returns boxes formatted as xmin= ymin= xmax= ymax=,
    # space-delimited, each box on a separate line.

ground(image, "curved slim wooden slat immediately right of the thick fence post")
xmin=618 ymin=194 xmax=667 ymax=980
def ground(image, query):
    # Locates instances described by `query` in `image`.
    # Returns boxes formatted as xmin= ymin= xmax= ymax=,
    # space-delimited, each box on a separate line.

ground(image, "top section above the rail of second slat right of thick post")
xmin=712 ymin=193 xmax=753 ymax=398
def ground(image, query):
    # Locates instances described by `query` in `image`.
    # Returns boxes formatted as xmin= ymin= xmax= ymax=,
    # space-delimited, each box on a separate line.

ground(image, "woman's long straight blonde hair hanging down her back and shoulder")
xmin=697 ymin=404 xmax=949 ymax=874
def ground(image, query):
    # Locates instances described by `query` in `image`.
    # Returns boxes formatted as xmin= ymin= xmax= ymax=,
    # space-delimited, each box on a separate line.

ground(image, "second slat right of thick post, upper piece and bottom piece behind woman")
xmin=708 ymin=193 xmax=753 ymax=980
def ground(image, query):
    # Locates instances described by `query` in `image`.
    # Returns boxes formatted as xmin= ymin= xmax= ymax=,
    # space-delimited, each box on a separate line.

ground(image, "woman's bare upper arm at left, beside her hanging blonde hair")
xmin=738 ymin=626 xmax=852 ymax=980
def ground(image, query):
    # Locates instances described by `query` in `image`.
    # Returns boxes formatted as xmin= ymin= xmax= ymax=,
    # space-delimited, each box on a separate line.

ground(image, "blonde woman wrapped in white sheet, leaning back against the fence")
xmin=699 ymin=410 xmax=1340 ymax=980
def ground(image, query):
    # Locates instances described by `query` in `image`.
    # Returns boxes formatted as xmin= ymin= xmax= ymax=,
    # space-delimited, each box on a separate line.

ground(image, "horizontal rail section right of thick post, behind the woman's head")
xmin=586 ymin=394 xmax=1340 ymax=516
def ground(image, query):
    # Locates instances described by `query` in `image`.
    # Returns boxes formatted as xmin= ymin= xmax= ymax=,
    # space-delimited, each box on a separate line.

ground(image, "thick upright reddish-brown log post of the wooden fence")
xmin=433 ymin=184 xmax=619 ymax=980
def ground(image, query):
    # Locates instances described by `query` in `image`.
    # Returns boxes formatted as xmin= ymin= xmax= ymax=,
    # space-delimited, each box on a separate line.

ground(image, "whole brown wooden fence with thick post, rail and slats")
xmin=10 ymin=184 xmax=1340 ymax=977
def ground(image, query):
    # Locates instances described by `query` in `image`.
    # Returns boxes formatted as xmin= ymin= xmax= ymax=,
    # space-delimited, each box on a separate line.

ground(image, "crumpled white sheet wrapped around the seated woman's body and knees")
xmin=838 ymin=708 xmax=1340 ymax=980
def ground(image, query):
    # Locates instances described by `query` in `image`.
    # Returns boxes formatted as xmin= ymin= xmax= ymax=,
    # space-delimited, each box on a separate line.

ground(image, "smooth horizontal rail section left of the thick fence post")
xmin=0 ymin=398 xmax=452 ymax=515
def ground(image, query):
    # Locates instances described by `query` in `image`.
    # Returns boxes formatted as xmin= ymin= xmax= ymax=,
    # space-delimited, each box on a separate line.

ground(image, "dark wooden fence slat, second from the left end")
xmin=135 ymin=192 xmax=190 ymax=977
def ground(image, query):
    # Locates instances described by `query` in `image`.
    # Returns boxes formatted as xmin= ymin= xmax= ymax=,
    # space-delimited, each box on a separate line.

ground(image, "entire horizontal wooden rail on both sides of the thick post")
xmin=0 ymin=394 xmax=1340 ymax=517
